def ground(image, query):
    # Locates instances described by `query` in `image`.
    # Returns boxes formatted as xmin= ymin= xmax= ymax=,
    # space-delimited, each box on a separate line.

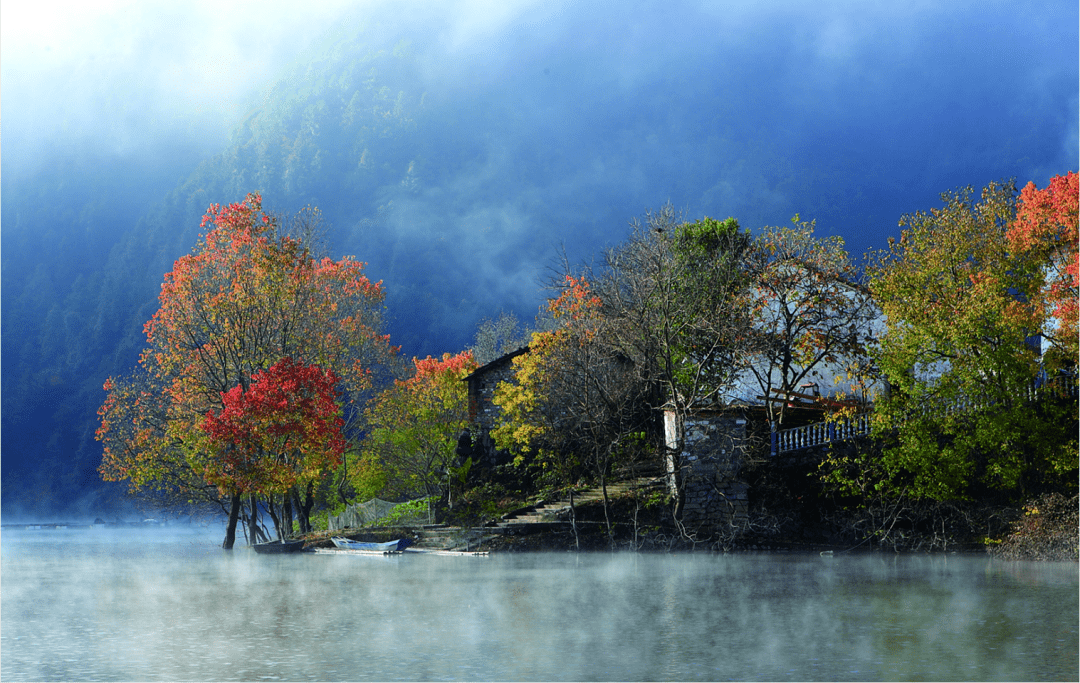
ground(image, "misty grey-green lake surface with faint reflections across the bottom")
xmin=0 ymin=530 xmax=1080 ymax=681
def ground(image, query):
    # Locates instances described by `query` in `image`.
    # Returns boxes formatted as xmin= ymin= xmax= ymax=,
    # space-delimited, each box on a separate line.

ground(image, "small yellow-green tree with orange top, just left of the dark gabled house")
xmin=354 ymin=351 xmax=476 ymax=504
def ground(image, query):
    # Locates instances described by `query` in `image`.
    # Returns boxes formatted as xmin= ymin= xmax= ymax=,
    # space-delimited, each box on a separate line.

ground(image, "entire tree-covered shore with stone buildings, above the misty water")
xmin=96 ymin=173 xmax=1080 ymax=562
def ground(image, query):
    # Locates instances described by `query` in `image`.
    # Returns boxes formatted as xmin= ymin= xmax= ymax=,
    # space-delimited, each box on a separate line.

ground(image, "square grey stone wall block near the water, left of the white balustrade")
xmin=664 ymin=413 xmax=747 ymax=538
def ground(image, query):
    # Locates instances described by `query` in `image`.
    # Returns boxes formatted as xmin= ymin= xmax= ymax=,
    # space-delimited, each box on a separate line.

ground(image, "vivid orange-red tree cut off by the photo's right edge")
xmin=1005 ymin=171 xmax=1080 ymax=369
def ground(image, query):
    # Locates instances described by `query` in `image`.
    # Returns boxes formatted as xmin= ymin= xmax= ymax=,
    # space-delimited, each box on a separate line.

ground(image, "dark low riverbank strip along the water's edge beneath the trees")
xmin=305 ymin=494 xmax=1080 ymax=562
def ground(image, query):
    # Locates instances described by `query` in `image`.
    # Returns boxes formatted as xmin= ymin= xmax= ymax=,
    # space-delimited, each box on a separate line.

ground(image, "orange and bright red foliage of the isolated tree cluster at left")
xmin=97 ymin=195 xmax=394 ymax=544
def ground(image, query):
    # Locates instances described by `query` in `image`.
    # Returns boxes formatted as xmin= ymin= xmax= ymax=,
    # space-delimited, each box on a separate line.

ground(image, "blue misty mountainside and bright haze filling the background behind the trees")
xmin=0 ymin=0 xmax=1080 ymax=517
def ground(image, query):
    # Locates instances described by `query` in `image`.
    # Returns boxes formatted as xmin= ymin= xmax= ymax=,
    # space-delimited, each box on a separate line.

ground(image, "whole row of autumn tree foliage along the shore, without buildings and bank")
xmin=97 ymin=178 xmax=1080 ymax=546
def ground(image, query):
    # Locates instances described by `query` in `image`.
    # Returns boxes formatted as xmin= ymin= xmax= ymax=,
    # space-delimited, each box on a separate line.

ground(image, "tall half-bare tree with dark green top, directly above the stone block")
xmin=595 ymin=205 xmax=753 ymax=488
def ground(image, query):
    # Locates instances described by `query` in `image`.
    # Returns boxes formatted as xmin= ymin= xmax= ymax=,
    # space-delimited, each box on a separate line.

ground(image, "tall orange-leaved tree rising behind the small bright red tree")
xmin=98 ymin=195 xmax=394 ymax=547
